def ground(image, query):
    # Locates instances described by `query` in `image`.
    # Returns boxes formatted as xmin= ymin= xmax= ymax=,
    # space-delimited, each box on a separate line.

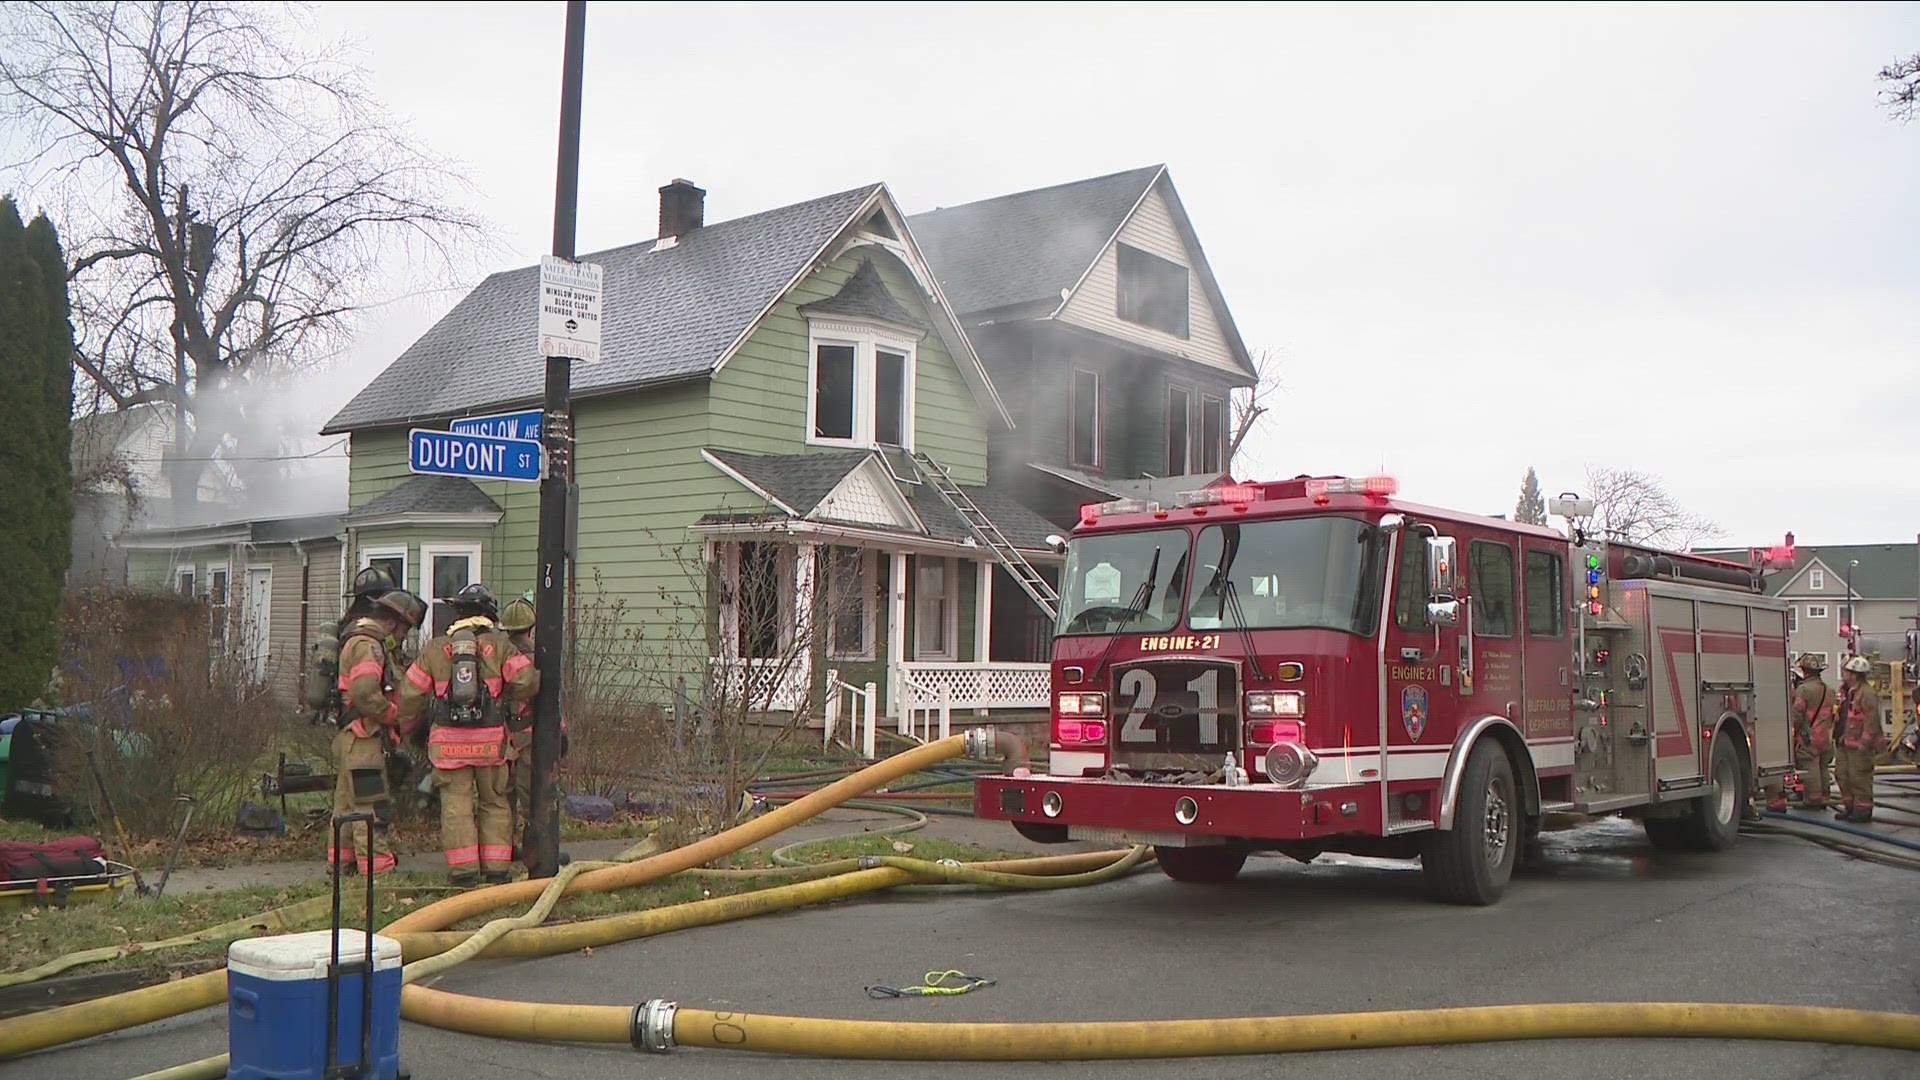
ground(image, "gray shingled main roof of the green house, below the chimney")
xmin=323 ymin=184 xmax=881 ymax=434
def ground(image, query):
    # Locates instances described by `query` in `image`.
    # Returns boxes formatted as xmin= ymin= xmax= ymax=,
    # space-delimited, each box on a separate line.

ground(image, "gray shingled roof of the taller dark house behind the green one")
xmin=906 ymin=165 xmax=1164 ymax=315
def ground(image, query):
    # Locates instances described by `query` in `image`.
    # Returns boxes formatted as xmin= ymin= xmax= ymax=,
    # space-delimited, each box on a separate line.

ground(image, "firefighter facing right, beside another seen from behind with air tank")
xmin=326 ymin=590 xmax=419 ymax=874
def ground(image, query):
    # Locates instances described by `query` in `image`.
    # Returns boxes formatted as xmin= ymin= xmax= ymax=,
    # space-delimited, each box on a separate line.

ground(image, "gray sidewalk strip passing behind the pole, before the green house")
xmin=153 ymin=809 xmax=1100 ymax=896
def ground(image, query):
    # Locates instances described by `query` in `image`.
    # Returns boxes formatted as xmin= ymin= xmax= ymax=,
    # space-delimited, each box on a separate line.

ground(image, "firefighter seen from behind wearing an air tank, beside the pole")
xmin=399 ymin=582 xmax=534 ymax=886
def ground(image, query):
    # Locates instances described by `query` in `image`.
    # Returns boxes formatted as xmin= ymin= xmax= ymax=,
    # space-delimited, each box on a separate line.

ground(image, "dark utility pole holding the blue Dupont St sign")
xmin=520 ymin=0 xmax=588 ymax=878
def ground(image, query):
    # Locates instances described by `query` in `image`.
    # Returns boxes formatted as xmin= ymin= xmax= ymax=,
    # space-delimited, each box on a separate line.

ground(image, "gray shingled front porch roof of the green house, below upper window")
xmin=703 ymin=450 xmax=1058 ymax=550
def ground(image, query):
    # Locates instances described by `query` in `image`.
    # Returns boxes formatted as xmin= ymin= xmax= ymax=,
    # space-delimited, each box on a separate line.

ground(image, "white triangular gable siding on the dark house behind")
xmin=1060 ymin=177 xmax=1244 ymax=375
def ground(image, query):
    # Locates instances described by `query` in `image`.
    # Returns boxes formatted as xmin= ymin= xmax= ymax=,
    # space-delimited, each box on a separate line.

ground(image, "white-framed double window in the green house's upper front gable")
xmin=806 ymin=319 xmax=918 ymax=450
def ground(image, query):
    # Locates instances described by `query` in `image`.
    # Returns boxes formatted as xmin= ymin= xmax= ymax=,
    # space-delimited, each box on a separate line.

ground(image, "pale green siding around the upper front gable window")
xmin=710 ymin=248 xmax=987 ymax=484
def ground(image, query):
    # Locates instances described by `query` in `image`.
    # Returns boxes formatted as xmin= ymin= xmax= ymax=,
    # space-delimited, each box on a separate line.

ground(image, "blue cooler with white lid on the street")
xmin=227 ymin=930 xmax=399 ymax=1080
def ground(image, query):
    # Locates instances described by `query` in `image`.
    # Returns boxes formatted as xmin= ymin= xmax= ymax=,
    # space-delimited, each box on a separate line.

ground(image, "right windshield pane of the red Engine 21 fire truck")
xmin=1187 ymin=515 xmax=1384 ymax=636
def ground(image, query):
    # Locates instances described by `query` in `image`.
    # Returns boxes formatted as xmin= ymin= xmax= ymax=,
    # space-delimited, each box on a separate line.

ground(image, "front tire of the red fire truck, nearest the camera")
xmin=1421 ymin=740 xmax=1526 ymax=907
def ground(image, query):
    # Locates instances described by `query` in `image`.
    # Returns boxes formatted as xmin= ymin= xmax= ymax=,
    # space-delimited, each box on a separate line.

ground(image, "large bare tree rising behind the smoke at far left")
xmin=0 ymin=0 xmax=480 ymax=505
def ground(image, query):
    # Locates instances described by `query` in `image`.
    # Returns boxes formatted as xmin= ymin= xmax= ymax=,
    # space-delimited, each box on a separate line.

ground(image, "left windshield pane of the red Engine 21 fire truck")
xmin=1060 ymin=528 xmax=1192 ymax=634
